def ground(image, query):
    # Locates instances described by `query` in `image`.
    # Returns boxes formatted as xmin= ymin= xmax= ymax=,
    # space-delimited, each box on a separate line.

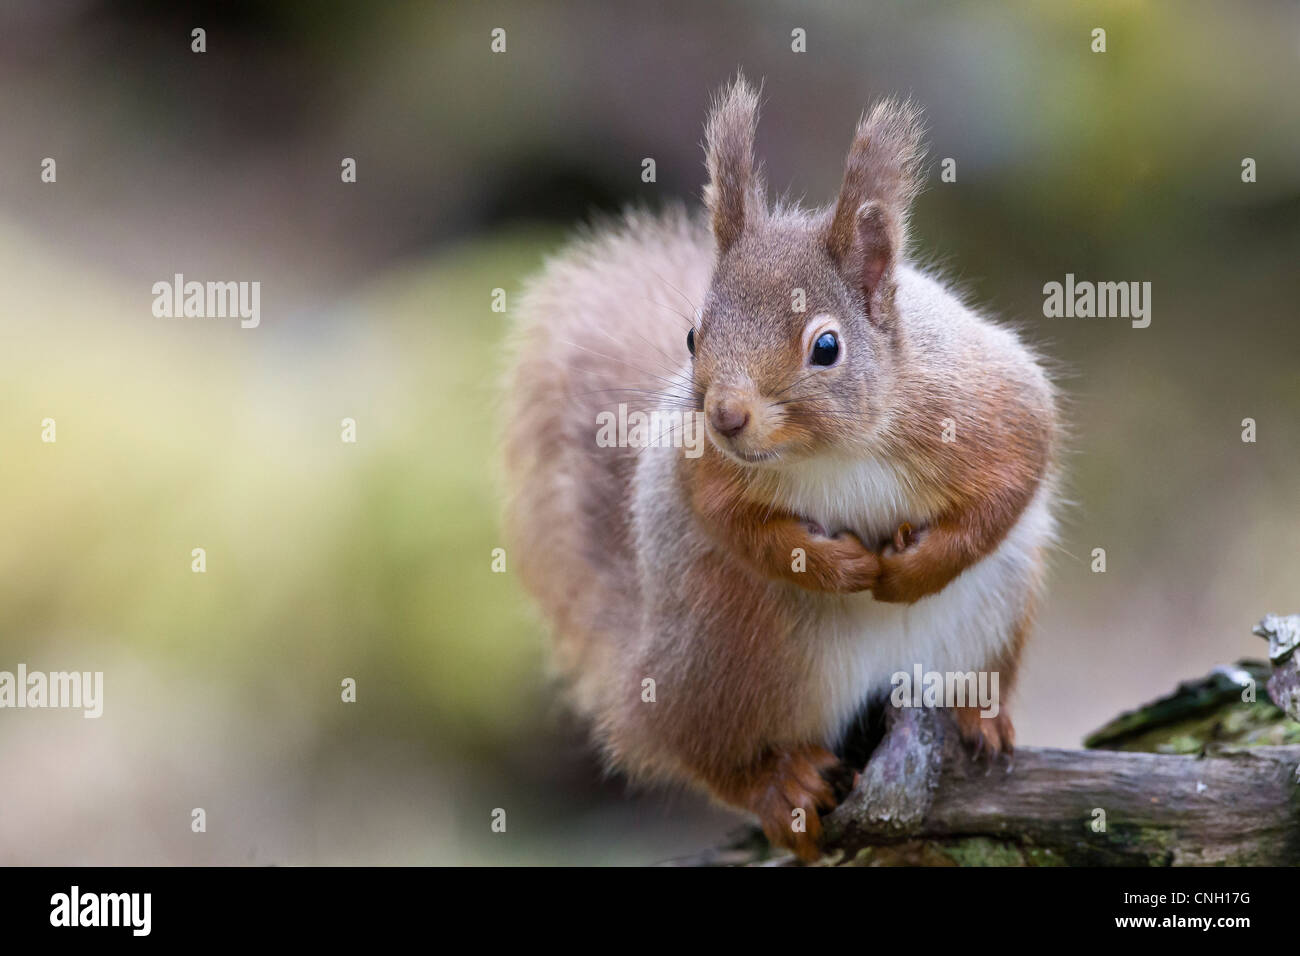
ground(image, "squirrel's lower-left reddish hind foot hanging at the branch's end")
xmin=748 ymin=747 xmax=850 ymax=862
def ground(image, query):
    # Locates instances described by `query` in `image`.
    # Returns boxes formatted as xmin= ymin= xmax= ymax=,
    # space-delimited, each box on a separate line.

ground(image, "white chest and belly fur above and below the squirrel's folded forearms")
xmin=764 ymin=459 xmax=1054 ymax=743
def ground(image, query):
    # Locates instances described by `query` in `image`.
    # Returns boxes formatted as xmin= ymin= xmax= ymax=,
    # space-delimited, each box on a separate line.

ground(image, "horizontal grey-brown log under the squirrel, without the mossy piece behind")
xmin=679 ymin=686 xmax=1300 ymax=866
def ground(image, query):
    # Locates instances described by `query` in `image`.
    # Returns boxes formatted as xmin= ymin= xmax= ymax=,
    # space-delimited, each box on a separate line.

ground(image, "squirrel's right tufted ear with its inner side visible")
xmin=826 ymin=100 xmax=924 ymax=312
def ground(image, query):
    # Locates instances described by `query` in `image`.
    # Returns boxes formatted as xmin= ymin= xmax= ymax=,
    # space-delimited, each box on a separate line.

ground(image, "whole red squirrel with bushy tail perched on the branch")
xmin=506 ymin=77 xmax=1060 ymax=858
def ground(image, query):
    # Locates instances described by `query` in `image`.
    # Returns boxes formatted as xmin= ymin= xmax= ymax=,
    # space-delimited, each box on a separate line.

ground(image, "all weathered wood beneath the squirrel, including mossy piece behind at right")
xmin=676 ymin=614 xmax=1300 ymax=866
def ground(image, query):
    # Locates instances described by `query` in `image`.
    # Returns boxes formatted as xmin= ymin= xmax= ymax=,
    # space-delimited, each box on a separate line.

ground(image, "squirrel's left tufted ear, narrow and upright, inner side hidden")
xmin=705 ymin=73 xmax=763 ymax=252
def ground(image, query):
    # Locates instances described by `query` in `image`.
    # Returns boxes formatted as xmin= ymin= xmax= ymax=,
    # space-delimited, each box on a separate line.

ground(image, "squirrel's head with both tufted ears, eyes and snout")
xmin=686 ymin=77 xmax=922 ymax=464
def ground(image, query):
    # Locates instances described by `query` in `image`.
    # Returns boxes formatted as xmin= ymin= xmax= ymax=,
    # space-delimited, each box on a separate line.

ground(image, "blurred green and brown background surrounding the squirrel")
xmin=0 ymin=0 xmax=1300 ymax=864
